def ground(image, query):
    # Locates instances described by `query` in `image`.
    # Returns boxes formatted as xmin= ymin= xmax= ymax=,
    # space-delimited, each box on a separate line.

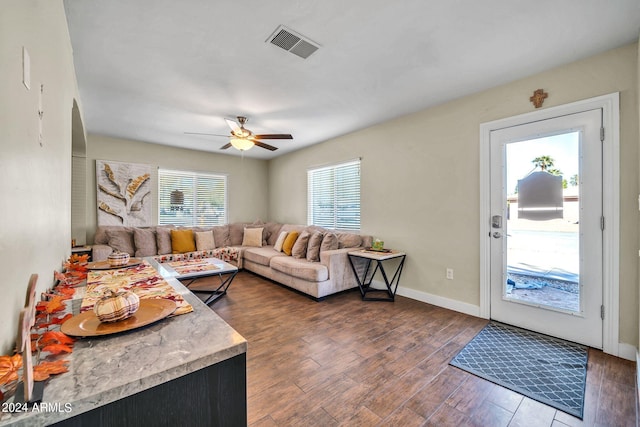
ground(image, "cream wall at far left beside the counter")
xmin=0 ymin=0 xmax=77 ymax=354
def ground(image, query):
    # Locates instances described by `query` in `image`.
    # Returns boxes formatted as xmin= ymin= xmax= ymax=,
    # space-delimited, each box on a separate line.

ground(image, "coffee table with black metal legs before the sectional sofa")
xmin=149 ymin=258 xmax=238 ymax=305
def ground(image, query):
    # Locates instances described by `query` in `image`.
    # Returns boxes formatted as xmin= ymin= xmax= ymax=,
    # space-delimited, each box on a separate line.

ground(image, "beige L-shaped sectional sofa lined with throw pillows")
xmin=93 ymin=222 xmax=372 ymax=299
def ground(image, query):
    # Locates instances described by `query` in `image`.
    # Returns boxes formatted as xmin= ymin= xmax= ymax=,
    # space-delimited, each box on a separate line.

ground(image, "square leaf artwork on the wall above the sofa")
xmin=96 ymin=160 xmax=151 ymax=226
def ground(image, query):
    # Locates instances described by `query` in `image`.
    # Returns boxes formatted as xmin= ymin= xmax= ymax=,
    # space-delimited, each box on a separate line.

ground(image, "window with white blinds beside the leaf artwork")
xmin=158 ymin=169 xmax=227 ymax=226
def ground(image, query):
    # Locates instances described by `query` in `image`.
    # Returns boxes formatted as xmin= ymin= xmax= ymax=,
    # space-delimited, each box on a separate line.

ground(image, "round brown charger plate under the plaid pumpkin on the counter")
xmin=60 ymin=299 xmax=176 ymax=337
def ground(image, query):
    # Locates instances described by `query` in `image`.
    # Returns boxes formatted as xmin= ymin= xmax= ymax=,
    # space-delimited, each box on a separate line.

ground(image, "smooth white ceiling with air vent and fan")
xmin=64 ymin=0 xmax=640 ymax=159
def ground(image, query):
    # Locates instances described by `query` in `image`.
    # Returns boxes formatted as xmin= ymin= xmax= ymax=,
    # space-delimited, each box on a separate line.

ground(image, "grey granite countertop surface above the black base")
xmin=0 ymin=279 xmax=247 ymax=427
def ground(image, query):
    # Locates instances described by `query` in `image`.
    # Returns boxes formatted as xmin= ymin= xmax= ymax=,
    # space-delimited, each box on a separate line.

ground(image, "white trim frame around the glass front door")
xmin=480 ymin=93 xmax=621 ymax=356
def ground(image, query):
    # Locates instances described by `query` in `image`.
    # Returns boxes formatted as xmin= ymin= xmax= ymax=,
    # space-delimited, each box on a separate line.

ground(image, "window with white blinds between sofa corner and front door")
xmin=307 ymin=159 xmax=360 ymax=231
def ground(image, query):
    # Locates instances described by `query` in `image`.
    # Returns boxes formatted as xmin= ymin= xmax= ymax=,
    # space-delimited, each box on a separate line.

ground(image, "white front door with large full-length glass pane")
xmin=487 ymin=109 xmax=603 ymax=348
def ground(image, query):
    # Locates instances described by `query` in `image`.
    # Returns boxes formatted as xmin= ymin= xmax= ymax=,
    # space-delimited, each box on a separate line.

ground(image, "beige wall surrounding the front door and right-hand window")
xmin=269 ymin=44 xmax=639 ymax=346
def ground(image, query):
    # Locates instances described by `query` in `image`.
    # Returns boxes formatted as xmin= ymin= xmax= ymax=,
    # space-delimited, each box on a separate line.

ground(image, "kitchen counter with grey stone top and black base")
xmin=0 ymin=279 xmax=247 ymax=427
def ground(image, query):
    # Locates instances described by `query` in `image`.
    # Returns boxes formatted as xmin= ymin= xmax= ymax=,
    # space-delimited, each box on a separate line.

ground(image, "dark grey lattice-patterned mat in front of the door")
xmin=450 ymin=322 xmax=587 ymax=419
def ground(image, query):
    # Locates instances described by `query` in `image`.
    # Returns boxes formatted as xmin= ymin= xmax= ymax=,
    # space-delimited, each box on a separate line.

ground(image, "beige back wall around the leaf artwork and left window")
xmin=87 ymin=134 xmax=269 ymax=242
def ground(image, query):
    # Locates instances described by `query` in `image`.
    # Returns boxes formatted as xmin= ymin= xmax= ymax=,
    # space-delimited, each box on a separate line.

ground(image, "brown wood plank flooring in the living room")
xmin=193 ymin=272 xmax=636 ymax=427
